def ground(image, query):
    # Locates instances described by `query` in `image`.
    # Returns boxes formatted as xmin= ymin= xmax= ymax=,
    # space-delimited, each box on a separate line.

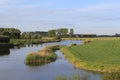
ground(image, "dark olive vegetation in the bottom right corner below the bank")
xmin=103 ymin=72 xmax=120 ymax=80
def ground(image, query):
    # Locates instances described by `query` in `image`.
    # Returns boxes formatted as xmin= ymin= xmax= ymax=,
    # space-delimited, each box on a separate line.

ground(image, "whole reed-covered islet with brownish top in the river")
xmin=25 ymin=45 xmax=59 ymax=66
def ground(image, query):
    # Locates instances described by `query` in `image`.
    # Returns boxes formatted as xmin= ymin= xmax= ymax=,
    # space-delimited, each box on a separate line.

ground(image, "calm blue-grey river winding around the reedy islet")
xmin=0 ymin=40 xmax=101 ymax=80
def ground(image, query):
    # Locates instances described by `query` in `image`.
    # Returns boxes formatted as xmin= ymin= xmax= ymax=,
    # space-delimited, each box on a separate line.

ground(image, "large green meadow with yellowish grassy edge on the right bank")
xmin=61 ymin=38 xmax=120 ymax=72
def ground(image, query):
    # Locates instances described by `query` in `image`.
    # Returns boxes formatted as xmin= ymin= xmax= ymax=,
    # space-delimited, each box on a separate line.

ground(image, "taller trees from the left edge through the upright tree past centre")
xmin=0 ymin=28 xmax=74 ymax=39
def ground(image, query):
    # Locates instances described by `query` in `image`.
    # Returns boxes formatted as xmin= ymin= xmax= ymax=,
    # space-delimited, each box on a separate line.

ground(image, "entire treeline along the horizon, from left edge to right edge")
xmin=0 ymin=28 xmax=120 ymax=41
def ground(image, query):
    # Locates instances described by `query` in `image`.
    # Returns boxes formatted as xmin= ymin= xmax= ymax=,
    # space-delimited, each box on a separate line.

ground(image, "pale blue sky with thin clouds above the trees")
xmin=0 ymin=0 xmax=120 ymax=35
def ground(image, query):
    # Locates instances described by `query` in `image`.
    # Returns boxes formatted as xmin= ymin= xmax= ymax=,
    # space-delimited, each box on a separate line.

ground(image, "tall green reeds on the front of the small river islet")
xmin=25 ymin=52 xmax=57 ymax=66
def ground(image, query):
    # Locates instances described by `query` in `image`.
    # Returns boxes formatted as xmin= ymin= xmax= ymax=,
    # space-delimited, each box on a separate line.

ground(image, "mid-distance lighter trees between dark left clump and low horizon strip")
xmin=21 ymin=28 xmax=74 ymax=39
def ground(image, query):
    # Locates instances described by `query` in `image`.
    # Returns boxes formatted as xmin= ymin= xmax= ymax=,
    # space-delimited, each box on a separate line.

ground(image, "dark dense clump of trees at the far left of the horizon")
xmin=0 ymin=28 xmax=21 ymax=39
